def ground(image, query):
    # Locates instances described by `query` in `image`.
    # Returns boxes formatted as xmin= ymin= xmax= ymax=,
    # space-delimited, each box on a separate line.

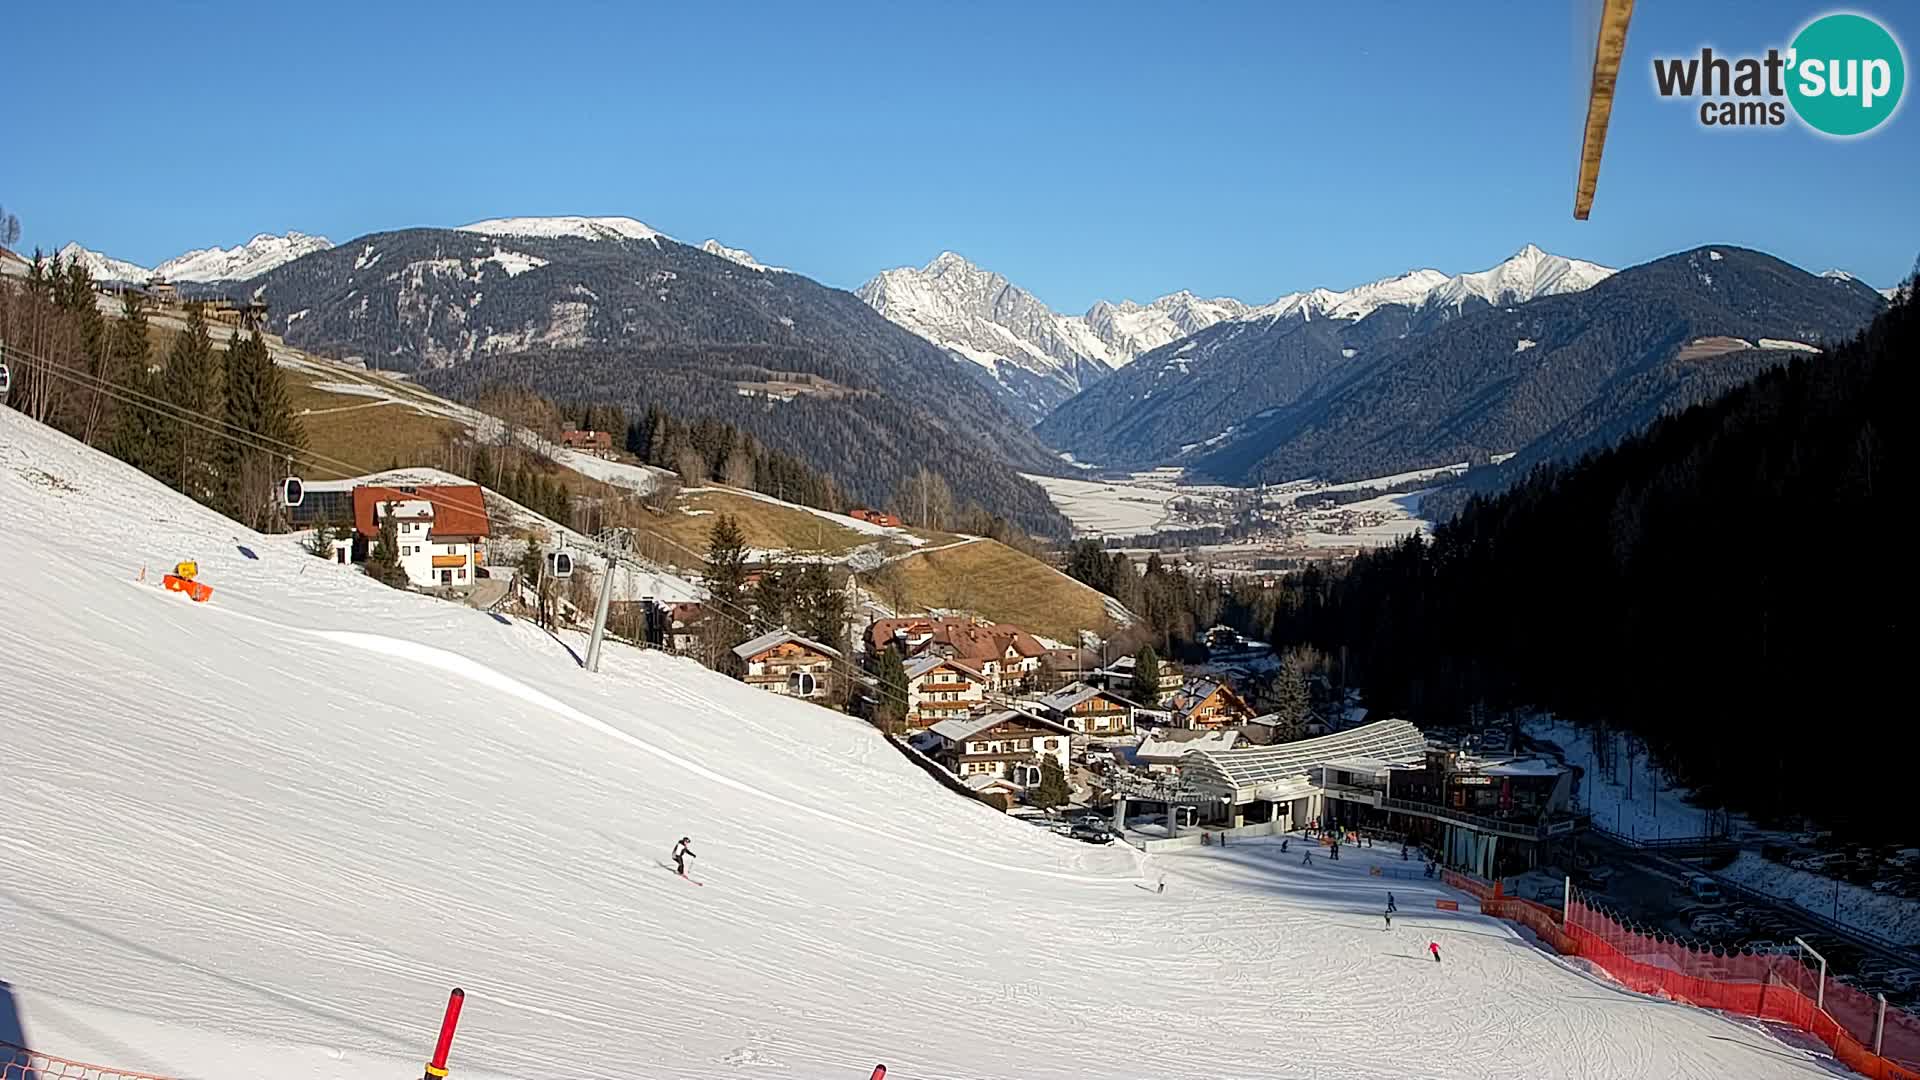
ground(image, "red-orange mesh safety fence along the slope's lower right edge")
xmin=1440 ymin=871 xmax=1920 ymax=1080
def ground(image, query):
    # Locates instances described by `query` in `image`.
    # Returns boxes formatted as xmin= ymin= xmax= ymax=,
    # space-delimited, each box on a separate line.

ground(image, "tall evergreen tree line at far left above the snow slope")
xmin=0 ymin=252 xmax=307 ymax=532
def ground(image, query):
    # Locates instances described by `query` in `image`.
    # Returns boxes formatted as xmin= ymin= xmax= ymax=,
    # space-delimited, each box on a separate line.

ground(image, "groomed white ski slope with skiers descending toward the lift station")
xmin=0 ymin=409 xmax=1826 ymax=1080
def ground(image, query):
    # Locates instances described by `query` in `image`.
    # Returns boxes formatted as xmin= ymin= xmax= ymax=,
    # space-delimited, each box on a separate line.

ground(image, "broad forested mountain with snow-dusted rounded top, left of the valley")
xmin=242 ymin=219 xmax=1066 ymax=534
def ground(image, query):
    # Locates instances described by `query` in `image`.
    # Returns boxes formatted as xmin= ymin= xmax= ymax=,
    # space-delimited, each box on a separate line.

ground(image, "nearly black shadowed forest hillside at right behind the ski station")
xmin=1273 ymin=275 xmax=1920 ymax=830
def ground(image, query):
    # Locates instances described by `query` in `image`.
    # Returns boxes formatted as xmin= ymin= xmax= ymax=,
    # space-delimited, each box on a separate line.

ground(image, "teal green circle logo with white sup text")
xmin=1788 ymin=13 xmax=1907 ymax=136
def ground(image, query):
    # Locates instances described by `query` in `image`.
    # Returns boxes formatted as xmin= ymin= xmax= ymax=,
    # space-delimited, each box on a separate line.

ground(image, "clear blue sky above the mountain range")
xmin=0 ymin=0 xmax=1920 ymax=311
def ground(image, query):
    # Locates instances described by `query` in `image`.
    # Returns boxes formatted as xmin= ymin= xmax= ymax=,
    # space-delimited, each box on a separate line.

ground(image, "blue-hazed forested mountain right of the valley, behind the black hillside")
xmin=1194 ymin=246 xmax=1884 ymax=482
